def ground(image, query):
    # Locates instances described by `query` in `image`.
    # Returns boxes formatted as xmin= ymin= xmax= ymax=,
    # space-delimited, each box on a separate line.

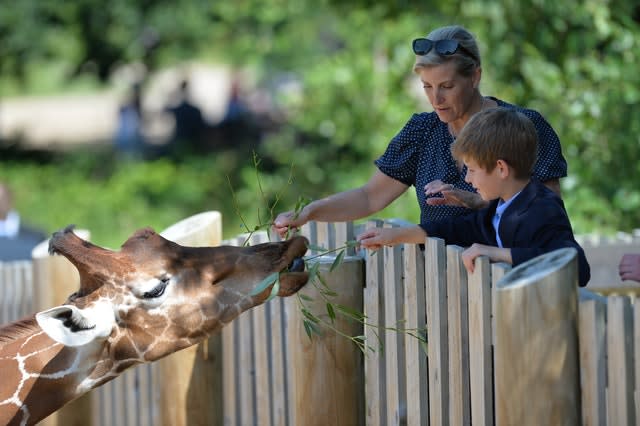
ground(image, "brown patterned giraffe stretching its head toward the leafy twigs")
xmin=0 ymin=226 xmax=309 ymax=425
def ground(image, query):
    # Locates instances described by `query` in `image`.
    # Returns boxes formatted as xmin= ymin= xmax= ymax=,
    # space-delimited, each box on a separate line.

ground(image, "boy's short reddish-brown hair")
xmin=451 ymin=107 xmax=538 ymax=179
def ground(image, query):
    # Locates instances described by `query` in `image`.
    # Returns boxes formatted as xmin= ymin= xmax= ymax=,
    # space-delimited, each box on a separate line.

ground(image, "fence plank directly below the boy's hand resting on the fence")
xmin=468 ymin=256 xmax=493 ymax=426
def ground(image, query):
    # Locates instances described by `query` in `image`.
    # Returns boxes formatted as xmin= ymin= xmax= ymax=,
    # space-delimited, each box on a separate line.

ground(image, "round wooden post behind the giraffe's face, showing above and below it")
xmin=154 ymin=211 xmax=223 ymax=426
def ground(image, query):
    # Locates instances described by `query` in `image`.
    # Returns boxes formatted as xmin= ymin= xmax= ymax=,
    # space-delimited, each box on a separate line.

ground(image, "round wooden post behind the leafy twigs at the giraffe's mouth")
xmin=285 ymin=256 xmax=364 ymax=426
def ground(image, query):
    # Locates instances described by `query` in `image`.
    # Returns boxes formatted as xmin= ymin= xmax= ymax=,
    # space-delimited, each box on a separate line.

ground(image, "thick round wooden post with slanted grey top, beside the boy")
xmin=495 ymin=248 xmax=580 ymax=426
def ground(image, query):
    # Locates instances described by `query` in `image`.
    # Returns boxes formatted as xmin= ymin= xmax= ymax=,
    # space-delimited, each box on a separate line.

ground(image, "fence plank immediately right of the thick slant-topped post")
xmin=578 ymin=290 xmax=608 ymax=426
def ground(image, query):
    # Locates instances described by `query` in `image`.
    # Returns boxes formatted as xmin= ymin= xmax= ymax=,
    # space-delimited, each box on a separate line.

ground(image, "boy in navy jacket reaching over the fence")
xmin=357 ymin=107 xmax=590 ymax=286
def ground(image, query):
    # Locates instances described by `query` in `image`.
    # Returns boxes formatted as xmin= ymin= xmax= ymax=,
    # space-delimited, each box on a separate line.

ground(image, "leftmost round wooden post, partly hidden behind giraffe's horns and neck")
xmin=32 ymin=229 xmax=92 ymax=426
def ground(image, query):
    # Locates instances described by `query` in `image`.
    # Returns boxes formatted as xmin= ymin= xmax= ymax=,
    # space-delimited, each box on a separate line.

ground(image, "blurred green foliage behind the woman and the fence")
xmin=0 ymin=0 xmax=640 ymax=247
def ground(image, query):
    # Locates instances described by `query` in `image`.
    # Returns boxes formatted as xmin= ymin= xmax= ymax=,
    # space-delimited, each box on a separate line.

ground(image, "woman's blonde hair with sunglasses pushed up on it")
xmin=413 ymin=25 xmax=481 ymax=77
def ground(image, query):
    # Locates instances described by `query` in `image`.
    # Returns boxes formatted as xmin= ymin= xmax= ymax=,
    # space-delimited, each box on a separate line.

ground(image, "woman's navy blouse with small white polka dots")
xmin=375 ymin=98 xmax=567 ymax=223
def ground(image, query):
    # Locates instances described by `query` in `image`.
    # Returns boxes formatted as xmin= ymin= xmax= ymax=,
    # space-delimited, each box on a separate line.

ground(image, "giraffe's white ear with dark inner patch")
xmin=36 ymin=305 xmax=116 ymax=346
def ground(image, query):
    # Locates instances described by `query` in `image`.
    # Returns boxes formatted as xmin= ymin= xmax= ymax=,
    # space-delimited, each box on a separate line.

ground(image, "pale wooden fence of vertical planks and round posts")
xmin=0 ymin=215 xmax=640 ymax=426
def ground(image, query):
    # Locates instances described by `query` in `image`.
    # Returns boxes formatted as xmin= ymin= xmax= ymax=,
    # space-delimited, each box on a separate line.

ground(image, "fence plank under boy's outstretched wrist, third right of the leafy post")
xmin=403 ymin=244 xmax=429 ymax=425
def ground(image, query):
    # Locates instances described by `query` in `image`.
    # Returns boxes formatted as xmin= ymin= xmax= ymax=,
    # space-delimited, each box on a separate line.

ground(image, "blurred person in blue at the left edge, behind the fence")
xmin=0 ymin=182 xmax=47 ymax=261
